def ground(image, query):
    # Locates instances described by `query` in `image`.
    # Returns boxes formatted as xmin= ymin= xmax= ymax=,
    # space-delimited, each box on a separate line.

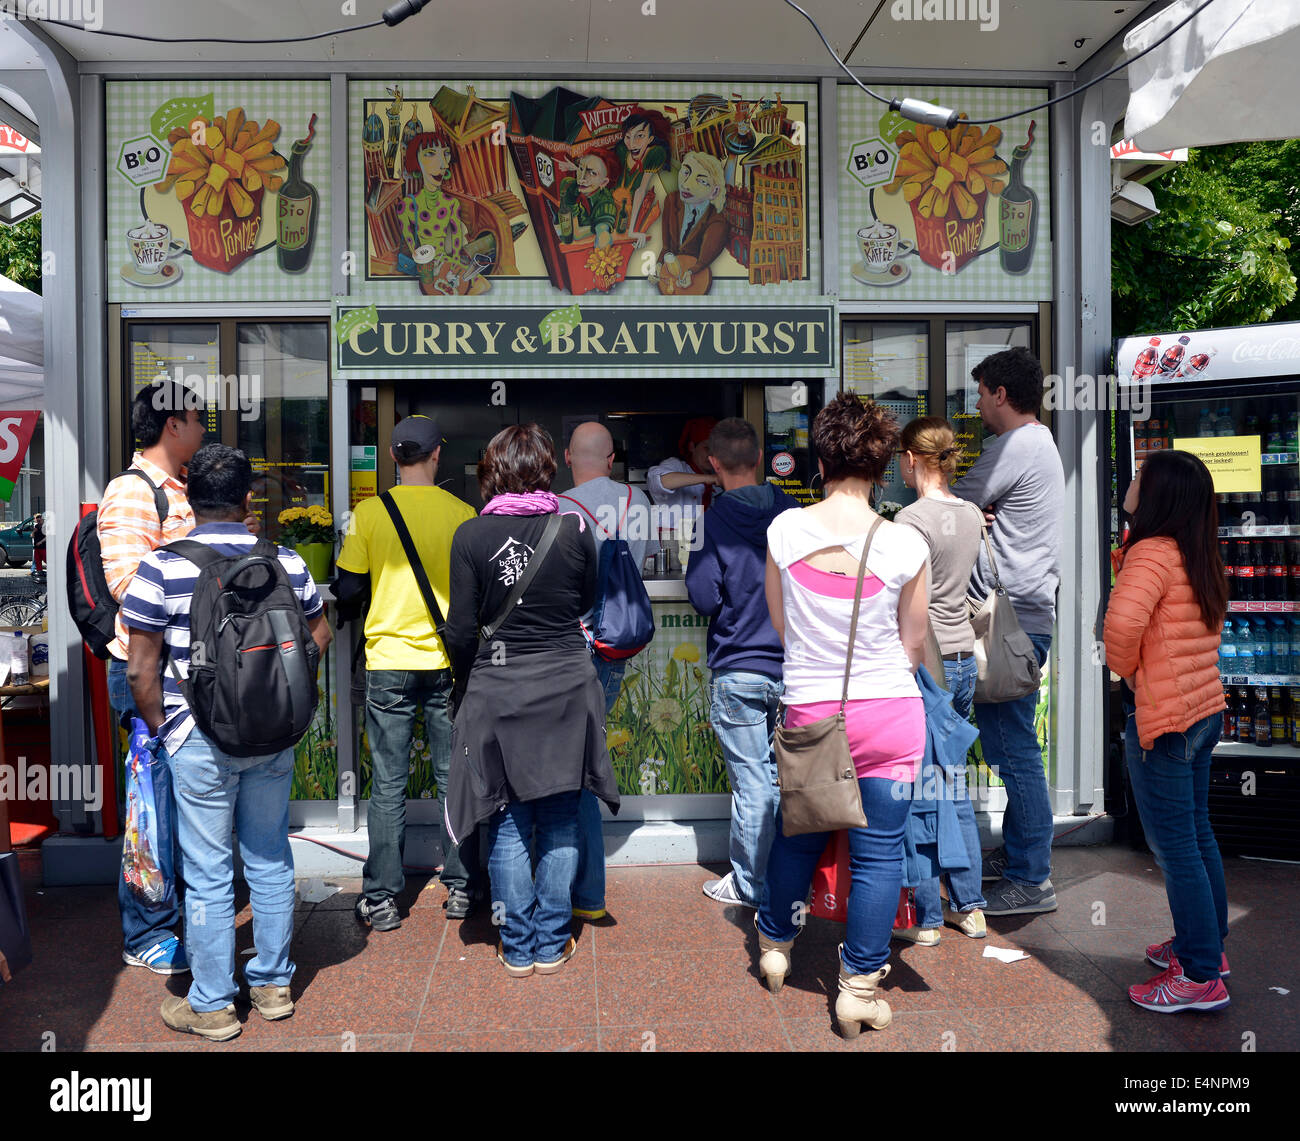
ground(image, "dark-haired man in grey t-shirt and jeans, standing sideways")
xmin=953 ymin=348 xmax=1065 ymax=915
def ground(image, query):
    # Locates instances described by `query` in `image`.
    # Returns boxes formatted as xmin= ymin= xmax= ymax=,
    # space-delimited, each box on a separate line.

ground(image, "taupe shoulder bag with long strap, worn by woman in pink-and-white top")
xmin=775 ymin=516 xmax=880 ymax=836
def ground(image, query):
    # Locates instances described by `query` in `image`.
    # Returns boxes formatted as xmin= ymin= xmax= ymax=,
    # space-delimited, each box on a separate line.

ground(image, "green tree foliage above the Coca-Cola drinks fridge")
xmin=1110 ymin=140 xmax=1300 ymax=337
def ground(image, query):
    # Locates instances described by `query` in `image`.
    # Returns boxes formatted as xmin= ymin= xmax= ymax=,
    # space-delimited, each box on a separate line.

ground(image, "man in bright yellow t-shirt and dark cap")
xmin=337 ymin=416 xmax=478 ymax=930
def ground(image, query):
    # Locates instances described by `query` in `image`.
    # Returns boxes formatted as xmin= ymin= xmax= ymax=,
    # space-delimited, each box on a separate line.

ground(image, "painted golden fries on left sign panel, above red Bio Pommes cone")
xmin=157 ymin=107 xmax=285 ymax=218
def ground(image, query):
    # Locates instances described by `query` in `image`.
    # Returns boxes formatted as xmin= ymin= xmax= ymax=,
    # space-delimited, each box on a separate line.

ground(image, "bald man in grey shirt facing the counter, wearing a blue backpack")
xmin=560 ymin=420 xmax=659 ymax=920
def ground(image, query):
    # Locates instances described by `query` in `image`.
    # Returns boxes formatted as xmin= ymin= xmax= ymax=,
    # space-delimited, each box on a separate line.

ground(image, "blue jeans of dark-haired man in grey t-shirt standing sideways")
xmin=975 ymin=634 xmax=1052 ymax=888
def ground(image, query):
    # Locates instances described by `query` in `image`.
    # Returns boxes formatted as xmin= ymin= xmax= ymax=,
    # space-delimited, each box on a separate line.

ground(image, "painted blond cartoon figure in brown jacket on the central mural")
xmin=657 ymin=151 xmax=731 ymax=295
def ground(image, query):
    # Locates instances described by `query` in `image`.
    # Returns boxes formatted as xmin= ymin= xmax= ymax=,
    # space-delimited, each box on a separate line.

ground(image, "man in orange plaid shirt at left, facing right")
xmin=96 ymin=378 xmax=259 ymax=975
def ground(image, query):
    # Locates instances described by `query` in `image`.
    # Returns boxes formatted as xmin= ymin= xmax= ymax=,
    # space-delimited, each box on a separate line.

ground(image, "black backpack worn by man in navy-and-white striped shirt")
xmin=159 ymin=539 xmax=320 ymax=756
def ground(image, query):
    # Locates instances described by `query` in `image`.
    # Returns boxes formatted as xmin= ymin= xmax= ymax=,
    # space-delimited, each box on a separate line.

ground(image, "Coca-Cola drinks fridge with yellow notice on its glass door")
xmin=1110 ymin=324 xmax=1300 ymax=859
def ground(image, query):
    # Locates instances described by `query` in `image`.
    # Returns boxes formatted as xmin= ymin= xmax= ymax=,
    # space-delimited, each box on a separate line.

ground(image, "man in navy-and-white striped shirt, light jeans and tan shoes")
xmin=121 ymin=443 xmax=330 ymax=1041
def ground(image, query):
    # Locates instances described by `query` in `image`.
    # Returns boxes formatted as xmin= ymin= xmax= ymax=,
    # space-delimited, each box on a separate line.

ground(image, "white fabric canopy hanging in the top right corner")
xmin=1125 ymin=0 xmax=1300 ymax=152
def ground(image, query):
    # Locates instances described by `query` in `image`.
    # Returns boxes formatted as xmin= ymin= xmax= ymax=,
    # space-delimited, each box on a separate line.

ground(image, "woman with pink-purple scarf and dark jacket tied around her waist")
xmin=445 ymin=424 xmax=619 ymax=979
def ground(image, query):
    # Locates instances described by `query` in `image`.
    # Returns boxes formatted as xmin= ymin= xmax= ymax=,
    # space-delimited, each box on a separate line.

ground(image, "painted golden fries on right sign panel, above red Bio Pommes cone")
xmin=884 ymin=122 xmax=1006 ymax=221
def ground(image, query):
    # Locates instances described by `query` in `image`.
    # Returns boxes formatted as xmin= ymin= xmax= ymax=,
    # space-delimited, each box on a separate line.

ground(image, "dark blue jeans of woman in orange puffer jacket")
xmin=1125 ymin=712 xmax=1227 ymax=982
